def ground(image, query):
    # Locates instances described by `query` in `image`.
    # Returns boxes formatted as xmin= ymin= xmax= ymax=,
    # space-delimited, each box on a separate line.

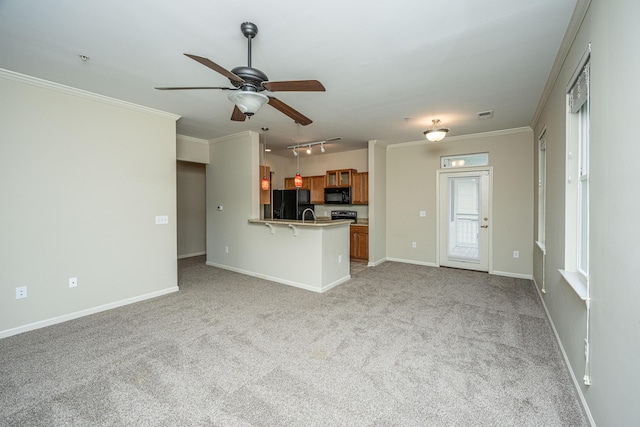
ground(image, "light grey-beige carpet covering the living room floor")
xmin=0 ymin=257 xmax=587 ymax=426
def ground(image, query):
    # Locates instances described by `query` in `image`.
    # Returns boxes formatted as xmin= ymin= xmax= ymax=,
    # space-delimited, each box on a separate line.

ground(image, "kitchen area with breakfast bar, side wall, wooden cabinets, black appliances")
xmin=206 ymin=132 xmax=370 ymax=292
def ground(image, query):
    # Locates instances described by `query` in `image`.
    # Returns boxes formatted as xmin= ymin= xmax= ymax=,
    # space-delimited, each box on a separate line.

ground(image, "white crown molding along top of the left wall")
xmin=0 ymin=68 xmax=180 ymax=121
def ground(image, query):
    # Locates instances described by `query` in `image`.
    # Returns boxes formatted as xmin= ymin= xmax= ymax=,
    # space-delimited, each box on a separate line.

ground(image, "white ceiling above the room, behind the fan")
xmin=0 ymin=0 xmax=577 ymax=157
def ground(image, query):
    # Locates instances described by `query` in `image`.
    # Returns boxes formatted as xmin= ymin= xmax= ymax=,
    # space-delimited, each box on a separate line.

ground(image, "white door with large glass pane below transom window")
xmin=438 ymin=170 xmax=490 ymax=271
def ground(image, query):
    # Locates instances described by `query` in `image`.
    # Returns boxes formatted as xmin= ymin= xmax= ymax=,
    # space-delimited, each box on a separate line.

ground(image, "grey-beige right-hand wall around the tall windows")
xmin=534 ymin=0 xmax=640 ymax=426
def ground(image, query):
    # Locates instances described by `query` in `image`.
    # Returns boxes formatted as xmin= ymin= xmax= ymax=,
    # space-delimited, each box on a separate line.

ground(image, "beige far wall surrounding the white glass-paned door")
xmin=386 ymin=128 xmax=533 ymax=277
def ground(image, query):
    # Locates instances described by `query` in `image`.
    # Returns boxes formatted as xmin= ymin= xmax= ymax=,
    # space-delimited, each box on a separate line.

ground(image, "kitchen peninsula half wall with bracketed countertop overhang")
xmin=249 ymin=219 xmax=352 ymax=292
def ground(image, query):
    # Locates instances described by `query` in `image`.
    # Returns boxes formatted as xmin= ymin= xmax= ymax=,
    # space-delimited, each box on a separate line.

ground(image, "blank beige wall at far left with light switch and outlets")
xmin=0 ymin=71 xmax=177 ymax=336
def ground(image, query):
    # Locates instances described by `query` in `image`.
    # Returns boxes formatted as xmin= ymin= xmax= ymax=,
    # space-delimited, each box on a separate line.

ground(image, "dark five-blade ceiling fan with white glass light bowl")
xmin=156 ymin=22 xmax=325 ymax=126
